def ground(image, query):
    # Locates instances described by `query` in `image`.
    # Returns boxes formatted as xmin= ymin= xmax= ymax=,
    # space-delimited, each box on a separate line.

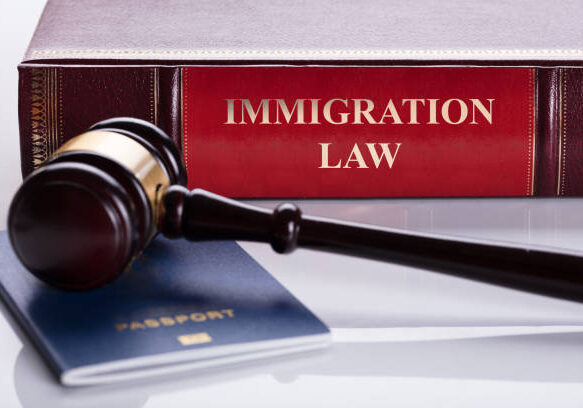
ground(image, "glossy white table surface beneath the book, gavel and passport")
xmin=0 ymin=0 xmax=583 ymax=408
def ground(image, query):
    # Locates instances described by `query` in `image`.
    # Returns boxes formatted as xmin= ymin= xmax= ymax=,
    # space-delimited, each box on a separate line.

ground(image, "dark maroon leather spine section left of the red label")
xmin=19 ymin=64 xmax=160 ymax=176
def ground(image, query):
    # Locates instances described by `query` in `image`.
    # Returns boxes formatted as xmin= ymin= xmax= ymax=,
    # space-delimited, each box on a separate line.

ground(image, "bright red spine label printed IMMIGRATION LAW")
xmin=182 ymin=67 xmax=535 ymax=197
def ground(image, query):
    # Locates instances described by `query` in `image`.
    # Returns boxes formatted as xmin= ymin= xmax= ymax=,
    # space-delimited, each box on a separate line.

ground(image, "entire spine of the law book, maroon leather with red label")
xmin=19 ymin=64 xmax=583 ymax=198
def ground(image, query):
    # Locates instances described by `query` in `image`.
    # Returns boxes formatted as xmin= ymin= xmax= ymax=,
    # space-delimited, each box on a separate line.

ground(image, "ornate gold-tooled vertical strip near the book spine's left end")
xmin=30 ymin=68 xmax=63 ymax=169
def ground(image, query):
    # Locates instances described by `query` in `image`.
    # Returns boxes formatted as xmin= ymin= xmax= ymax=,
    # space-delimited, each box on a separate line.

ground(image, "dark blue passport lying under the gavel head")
xmin=0 ymin=232 xmax=330 ymax=385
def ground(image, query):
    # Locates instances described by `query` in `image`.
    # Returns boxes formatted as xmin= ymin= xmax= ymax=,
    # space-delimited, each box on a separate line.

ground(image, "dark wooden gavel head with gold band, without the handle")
xmin=8 ymin=118 xmax=186 ymax=290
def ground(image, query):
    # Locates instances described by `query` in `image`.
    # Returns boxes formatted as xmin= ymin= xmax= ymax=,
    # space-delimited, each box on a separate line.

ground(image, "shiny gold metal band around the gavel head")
xmin=55 ymin=130 xmax=170 ymax=221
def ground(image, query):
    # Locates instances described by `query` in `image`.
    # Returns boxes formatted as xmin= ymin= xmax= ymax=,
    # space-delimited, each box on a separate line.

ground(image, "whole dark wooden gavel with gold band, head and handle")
xmin=8 ymin=118 xmax=583 ymax=301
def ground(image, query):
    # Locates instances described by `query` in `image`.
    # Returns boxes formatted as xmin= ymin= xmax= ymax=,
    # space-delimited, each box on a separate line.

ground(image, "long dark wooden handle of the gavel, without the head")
xmin=159 ymin=186 xmax=583 ymax=301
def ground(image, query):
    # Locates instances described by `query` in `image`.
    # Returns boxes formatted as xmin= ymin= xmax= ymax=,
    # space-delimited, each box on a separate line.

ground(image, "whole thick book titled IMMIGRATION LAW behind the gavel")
xmin=19 ymin=0 xmax=583 ymax=197
